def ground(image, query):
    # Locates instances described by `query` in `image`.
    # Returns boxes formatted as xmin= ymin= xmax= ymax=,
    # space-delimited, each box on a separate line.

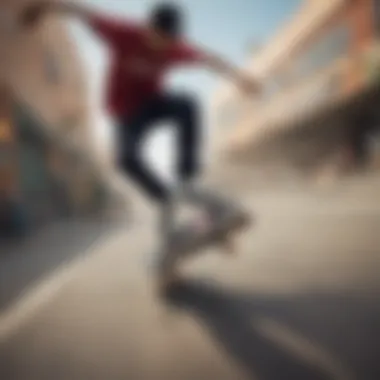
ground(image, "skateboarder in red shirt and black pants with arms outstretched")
xmin=21 ymin=1 xmax=259 ymax=246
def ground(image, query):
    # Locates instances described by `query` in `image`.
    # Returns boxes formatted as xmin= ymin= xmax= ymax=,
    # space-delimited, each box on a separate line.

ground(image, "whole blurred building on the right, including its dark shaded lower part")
xmin=213 ymin=1 xmax=379 ymax=183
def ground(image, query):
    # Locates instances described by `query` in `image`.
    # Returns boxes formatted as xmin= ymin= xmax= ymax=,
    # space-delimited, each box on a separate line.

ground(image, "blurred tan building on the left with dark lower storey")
xmin=0 ymin=0 xmax=112 ymax=235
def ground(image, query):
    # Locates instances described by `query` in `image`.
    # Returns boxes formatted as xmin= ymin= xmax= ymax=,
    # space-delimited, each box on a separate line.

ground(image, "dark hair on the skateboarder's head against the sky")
xmin=149 ymin=3 xmax=183 ymax=37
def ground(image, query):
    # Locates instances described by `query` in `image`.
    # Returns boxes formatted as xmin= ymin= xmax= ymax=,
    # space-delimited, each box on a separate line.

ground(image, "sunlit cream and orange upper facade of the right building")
xmin=213 ymin=0 xmax=380 ymax=162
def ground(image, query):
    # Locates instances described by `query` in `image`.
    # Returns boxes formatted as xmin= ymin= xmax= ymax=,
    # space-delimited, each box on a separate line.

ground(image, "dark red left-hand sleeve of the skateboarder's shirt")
xmin=89 ymin=15 xmax=137 ymax=44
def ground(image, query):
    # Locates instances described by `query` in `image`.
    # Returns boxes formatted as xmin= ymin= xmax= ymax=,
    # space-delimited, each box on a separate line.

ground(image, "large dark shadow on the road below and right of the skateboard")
xmin=167 ymin=281 xmax=380 ymax=380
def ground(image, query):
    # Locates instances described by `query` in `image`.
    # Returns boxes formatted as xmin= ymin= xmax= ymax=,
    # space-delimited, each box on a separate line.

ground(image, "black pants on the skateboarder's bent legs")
xmin=117 ymin=94 xmax=201 ymax=202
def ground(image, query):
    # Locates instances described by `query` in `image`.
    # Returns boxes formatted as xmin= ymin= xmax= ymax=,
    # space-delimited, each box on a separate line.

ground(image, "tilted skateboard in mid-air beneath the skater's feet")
xmin=158 ymin=209 xmax=252 ymax=293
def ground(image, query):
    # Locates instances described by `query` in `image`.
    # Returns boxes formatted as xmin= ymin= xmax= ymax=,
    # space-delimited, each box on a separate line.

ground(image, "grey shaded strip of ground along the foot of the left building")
xmin=0 ymin=220 xmax=119 ymax=312
